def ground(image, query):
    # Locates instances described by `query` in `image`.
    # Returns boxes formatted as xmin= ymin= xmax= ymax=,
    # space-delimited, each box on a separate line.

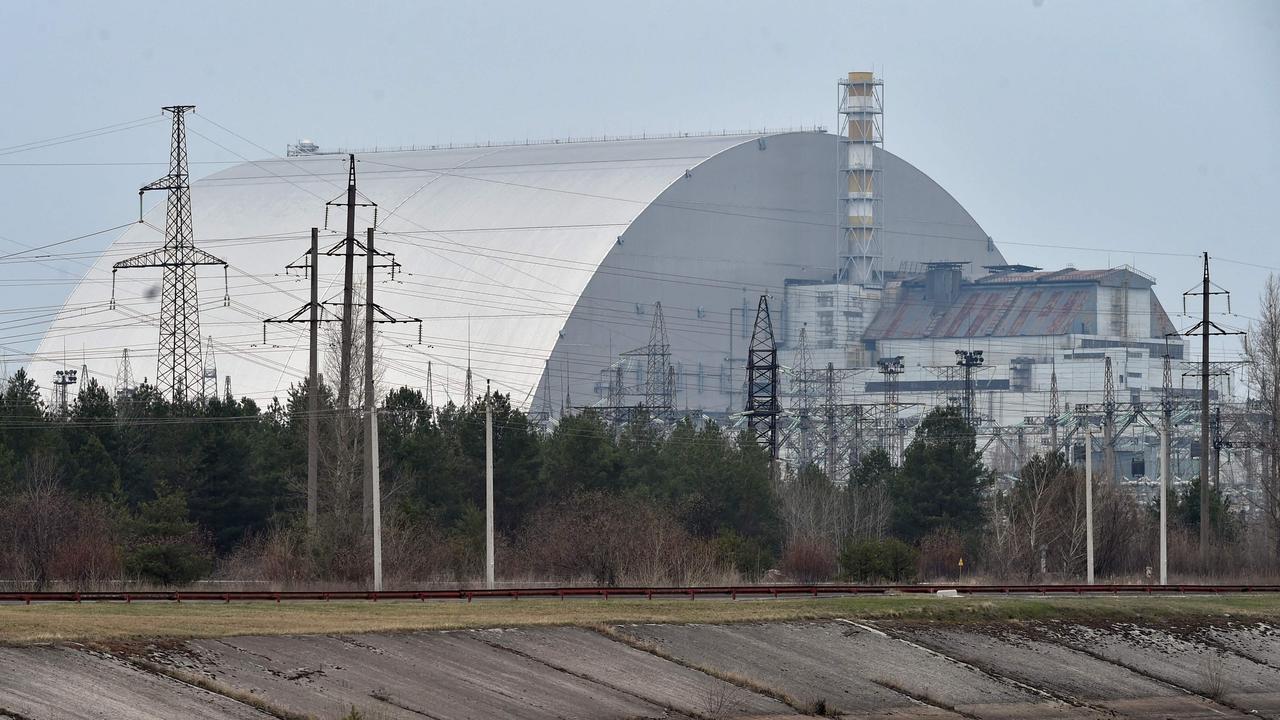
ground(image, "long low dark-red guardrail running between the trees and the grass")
xmin=0 ymin=584 xmax=1280 ymax=605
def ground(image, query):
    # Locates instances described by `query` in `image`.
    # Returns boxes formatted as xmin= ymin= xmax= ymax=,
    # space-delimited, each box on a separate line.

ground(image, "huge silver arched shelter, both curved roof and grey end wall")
xmin=32 ymin=133 xmax=1004 ymax=405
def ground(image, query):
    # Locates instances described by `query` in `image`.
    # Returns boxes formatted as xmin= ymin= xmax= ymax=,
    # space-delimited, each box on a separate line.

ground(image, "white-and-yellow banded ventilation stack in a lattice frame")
xmin=837 ymin=72 xmax=884 ymax=287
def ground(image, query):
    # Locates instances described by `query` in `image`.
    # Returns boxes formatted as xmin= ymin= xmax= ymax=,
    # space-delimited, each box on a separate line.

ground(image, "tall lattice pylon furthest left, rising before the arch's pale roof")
xmin=111 ymin=105 xmax=230 ymax=402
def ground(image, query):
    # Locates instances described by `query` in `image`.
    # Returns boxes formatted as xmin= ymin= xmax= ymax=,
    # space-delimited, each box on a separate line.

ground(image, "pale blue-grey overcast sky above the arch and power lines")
xmin=0 ymin=0 xmax=1280 ymax=379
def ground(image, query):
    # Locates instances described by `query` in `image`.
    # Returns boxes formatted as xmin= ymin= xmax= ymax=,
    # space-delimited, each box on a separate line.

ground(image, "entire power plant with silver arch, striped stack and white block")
xmin=32 ymin=73 xmax=1183 ymax=481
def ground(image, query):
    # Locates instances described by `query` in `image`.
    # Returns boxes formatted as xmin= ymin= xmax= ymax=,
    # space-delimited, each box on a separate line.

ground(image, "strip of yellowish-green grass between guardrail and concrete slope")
xmin=0 ymin=594 xmax=1280 ymax=644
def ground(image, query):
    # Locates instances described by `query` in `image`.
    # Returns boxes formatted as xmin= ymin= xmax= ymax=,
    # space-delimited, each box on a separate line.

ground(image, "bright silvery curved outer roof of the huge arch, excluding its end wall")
xmin=33 ymin=135 xmax=756 ymax=400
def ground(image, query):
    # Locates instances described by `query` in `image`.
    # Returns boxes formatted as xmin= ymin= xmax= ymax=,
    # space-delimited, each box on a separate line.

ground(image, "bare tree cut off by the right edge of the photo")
xmin=1244 ymin=274 xmax=1280 ymax=561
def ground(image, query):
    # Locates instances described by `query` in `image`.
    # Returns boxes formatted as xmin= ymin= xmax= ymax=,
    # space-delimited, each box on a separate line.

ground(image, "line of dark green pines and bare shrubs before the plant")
xmin=0 ymin=370 xmax=1264 ymax=587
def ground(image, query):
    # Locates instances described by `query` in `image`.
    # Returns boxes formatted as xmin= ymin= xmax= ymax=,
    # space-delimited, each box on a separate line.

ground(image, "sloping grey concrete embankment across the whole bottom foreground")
xmin=0 ymin=619 xmax=1280 ymax=720
